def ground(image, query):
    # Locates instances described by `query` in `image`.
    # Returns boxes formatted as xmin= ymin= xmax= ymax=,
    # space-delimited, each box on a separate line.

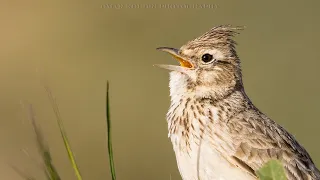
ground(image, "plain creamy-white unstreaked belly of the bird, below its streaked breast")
xmin=171 ymin=131 xmax=256 ymax=180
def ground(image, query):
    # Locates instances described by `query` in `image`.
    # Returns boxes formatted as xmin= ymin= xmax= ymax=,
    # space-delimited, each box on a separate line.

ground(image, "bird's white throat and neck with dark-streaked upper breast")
xmin=167 ymin=71 xmax=251 ymax=148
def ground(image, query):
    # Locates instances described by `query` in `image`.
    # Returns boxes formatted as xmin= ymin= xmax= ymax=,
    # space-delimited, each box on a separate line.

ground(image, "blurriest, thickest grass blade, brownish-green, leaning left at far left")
xmin=29 ymin=105 xmax=61 ymax=180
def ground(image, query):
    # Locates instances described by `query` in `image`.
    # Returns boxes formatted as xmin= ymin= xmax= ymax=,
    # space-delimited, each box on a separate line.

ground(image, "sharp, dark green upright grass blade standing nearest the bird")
xmin=106 ymin=81 xmax=116 ymax=180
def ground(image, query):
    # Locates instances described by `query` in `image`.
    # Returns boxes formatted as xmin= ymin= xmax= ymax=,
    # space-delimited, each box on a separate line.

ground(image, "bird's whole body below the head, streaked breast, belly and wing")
xmin=167 ymin=72 xmax=320 ymax=180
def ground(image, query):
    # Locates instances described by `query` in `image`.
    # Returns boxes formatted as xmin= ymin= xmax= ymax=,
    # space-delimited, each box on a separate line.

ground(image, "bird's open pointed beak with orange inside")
xmin=156 ymin=47 xmax=194 ymax=71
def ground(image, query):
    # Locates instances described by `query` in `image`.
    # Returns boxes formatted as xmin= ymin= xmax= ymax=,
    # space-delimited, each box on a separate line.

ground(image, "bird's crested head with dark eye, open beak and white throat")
xmin=157 ymin=25 xmax=242 ymax=98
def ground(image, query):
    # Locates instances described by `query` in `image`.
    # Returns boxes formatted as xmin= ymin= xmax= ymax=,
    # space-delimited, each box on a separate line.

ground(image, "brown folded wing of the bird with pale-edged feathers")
xmin=225 ymin=111 xmax=320 ymax=180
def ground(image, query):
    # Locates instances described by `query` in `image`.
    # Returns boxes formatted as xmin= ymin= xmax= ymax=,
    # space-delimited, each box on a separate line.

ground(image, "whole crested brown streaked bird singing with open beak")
xmin=157 ymin=25 xmax=320 ymax=180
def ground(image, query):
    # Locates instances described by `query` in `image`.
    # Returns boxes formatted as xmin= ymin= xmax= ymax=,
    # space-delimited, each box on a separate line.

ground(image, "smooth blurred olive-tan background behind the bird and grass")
xmin=0 ymin=0 xmax=320 ymax=180
